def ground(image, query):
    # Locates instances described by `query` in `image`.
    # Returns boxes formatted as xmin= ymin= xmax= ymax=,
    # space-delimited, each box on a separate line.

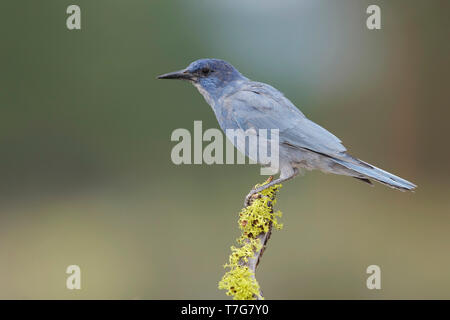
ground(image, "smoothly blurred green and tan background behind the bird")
xmin=0 ymin=0 xmax=450 ymax=299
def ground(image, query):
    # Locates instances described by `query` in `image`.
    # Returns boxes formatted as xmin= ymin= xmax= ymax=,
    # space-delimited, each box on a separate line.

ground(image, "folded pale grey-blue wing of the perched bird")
xmin=223 ymin=82 xmax=348 ymax=160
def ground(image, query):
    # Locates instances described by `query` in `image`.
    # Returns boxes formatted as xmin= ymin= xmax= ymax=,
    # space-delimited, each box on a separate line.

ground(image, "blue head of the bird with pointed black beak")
xmin=158 ymin=59 xmax=246 ymax=97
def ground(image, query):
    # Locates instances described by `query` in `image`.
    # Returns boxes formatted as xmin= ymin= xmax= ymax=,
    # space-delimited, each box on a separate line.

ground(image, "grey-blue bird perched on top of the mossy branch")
xmin=158 ymin=59 xmax=416 ymax=205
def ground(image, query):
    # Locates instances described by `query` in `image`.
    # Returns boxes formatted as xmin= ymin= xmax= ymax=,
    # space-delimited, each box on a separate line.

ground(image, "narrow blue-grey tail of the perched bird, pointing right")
xmin=333 ymin=159 xmax=417 ymax=191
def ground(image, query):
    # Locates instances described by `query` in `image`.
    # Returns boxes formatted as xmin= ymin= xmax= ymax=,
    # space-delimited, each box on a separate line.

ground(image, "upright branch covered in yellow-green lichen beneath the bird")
xmin=219 ymin=177 xmax=282 ymax=300
